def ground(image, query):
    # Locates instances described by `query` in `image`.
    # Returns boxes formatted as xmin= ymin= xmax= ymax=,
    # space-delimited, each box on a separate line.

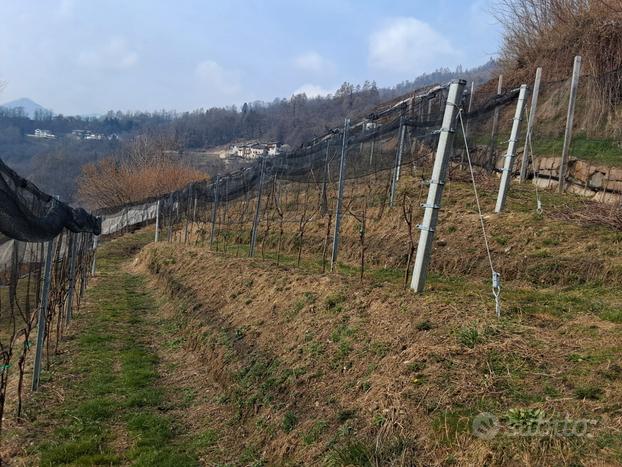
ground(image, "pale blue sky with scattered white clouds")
xmin=0 ymin=0 xmax=501 ymax=115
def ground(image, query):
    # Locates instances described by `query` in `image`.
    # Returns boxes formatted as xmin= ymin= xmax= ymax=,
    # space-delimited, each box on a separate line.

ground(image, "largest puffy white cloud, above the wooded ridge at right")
xmin=369 ymin=17 xmax=461 ymax=74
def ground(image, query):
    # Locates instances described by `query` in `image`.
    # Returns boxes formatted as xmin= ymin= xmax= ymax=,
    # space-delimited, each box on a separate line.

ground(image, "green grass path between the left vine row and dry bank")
xmin=9 ymin=234 xmax=198 ymax=467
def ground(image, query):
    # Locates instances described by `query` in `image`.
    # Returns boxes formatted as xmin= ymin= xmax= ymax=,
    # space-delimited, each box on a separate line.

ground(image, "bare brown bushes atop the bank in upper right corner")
xmin=497 ymin=0 xmax=622 ymax=114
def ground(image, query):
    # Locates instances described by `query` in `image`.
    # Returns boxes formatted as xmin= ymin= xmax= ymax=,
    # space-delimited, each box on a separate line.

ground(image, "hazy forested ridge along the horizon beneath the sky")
xmin=0 ymin=61 xmax=496 ymax=202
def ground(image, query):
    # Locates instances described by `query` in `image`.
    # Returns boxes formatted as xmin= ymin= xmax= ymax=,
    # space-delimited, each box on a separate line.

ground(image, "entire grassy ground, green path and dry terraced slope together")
xmin=6 ymin=172 xmax=622 ymax=466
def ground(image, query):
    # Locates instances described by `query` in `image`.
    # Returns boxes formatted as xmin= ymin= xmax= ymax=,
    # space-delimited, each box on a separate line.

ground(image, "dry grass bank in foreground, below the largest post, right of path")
xmin=141 ymin=239 xmax=622 ymax=465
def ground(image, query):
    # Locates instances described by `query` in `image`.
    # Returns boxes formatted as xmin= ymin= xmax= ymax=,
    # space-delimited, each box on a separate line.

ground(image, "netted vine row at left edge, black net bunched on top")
xmin=0 ymin=157 xmax=101 ymax=438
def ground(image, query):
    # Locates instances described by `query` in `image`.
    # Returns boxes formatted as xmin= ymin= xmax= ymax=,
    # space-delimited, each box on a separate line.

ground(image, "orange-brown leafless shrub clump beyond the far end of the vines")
xmin=78 ymin=136 xmax=208 ymax=209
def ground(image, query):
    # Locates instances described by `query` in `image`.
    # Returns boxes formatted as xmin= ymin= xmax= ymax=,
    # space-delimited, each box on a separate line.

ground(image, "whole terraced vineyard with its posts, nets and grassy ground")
xmin=0 ymin=66 xmax=622 ymax=465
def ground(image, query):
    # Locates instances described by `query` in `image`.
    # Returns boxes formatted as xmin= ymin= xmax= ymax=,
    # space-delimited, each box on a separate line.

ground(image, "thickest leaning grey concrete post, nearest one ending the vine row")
xmin=410 ymin=80 xmax=466 ymax=293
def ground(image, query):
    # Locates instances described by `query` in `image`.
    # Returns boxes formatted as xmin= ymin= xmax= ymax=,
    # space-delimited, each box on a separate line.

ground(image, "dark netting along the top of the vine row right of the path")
xmin=98 ymin=79 xmax=518 ymax=235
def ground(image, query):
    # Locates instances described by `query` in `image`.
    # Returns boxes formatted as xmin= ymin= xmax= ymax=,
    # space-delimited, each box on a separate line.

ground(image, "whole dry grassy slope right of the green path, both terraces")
xmin=129 ymin=168 xmax=622 ymax=465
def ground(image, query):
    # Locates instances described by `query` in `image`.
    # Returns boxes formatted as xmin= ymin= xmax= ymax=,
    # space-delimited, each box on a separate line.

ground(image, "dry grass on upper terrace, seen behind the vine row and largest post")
xmin=177 ymin=171 xmax=622 ymax=286
